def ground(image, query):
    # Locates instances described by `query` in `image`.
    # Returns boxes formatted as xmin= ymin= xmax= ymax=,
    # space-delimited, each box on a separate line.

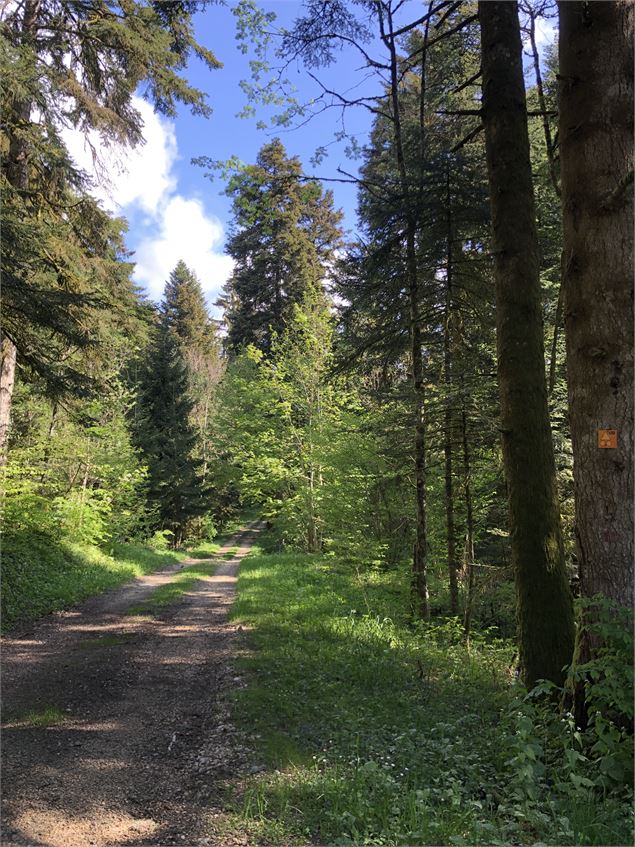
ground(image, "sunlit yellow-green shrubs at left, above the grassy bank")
xmin=2 ymin=379 xmax=152 ymax=544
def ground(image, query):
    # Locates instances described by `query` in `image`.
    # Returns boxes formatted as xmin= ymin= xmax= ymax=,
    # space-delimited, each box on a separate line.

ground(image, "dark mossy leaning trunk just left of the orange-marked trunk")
xmin=478 ymin=0 xmax=573 ymax=686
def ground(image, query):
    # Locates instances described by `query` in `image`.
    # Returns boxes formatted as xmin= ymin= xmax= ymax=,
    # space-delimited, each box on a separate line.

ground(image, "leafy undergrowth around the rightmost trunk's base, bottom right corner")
xmin=496 ymin=596 xmax=634 ymax=844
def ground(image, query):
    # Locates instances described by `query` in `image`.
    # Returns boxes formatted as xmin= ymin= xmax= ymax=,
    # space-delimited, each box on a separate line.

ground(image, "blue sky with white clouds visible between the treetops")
xmin=62 ymin=0 xmax=552 ymax=316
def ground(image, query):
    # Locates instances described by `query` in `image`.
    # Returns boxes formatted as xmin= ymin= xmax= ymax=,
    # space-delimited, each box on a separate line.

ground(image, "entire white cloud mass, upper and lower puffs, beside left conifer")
xmin=64 ymin=98 xmax=233 ymax=302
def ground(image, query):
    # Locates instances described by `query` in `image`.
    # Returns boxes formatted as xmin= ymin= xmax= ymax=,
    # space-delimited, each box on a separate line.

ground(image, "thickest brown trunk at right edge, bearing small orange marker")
xmin=560 ymin=0 xmax=634 ymax=606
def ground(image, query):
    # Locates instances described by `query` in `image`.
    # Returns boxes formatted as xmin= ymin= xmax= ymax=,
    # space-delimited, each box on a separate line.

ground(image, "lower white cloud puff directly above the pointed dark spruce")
xmin=134 ymin=194 xmax=233 ymax=299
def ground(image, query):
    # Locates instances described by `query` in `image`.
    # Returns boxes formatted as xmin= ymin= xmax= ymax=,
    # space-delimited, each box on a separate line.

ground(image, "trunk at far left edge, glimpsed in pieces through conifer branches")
xmin=0 ymin=0 xmax=40 ymax=466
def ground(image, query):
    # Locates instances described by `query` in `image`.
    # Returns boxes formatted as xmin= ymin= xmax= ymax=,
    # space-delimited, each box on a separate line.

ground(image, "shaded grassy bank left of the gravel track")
xmin=2 ymin=534 xmax=184 ymax=632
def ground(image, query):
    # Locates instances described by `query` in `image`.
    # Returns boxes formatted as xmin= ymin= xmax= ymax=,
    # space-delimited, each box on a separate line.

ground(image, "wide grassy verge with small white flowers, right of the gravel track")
xmin=227 ymin=553 xmax=628 ymax=845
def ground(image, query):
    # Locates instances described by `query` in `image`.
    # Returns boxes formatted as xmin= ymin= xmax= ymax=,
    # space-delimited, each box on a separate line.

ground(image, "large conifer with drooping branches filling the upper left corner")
xmin=0 ymin=0 xmax=218 ymax=458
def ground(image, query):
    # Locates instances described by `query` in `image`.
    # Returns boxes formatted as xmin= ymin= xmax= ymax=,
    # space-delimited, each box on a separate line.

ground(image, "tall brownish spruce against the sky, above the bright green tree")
xmin=221 ymin=139 xmax=341 ymax=352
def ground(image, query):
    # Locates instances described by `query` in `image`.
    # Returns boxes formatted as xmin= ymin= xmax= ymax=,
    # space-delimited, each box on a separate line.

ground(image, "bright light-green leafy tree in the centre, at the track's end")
xmin=216 ymin=296 xmax=388 ymax=551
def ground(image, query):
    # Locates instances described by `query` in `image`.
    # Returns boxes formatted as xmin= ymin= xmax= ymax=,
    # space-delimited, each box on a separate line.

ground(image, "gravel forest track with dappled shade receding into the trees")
xmin=2 ymin=522 xmax=262 ymax=847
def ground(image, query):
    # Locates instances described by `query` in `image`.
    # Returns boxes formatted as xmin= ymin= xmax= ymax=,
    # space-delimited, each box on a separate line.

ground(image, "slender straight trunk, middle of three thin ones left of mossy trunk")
xmin=443 ymin=168 xmax=459 ymax=615
